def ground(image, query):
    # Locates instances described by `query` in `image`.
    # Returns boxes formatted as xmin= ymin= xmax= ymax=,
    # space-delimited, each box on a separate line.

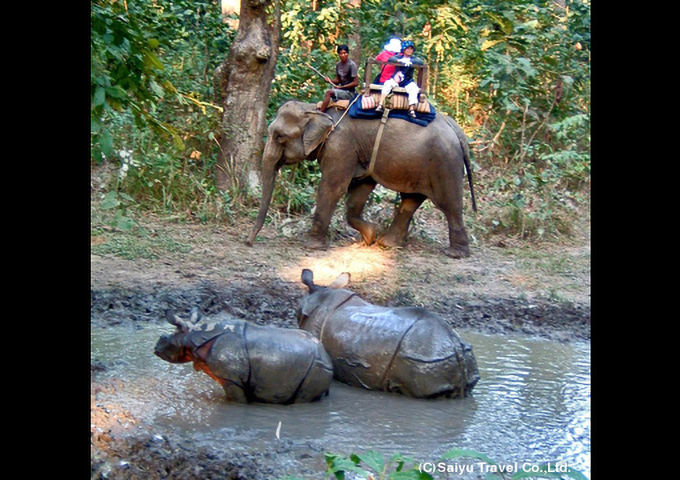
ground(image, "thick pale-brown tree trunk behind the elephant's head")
xmin=215 ymin=0 xmax=281 ymax=192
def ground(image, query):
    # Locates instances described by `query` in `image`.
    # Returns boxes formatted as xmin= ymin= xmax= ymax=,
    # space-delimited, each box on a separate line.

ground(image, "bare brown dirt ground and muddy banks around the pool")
xmin=91 ymin=210 xmax=590 ymax=480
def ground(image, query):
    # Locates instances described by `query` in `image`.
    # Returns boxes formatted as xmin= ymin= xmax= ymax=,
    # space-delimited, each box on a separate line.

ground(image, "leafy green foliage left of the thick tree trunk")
xmin=91 ymin=0 xmax=235 ymax=221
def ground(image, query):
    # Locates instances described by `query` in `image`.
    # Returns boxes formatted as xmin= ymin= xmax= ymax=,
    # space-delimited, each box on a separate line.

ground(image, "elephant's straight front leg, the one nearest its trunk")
xmin=309 ymin=172 xmax=352 ymax=250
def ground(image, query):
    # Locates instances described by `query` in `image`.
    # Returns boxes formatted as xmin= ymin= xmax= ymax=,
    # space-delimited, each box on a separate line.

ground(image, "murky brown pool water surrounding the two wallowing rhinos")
xmin=91 ymin=324 xmax=590 ymax=478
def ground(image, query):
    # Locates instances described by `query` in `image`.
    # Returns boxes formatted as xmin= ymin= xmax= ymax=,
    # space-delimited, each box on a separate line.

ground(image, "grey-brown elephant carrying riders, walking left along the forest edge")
xmin=246 ymin=100 xmax=477 ymax=258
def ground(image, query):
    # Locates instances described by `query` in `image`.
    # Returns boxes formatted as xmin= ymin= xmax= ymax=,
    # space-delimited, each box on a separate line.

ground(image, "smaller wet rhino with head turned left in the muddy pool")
xmin=154 ymin=308 xmax=333 ymax=405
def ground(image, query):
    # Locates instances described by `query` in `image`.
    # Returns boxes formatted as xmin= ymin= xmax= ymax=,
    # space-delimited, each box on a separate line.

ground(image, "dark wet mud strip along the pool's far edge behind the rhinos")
xmin=90 ymin=281 xmax=590 ymax=341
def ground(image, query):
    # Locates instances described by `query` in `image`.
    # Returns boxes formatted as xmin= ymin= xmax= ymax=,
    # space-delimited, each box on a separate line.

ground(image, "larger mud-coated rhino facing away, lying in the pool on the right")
xmin=298 ymin=269 xmax=480 ymax=398
